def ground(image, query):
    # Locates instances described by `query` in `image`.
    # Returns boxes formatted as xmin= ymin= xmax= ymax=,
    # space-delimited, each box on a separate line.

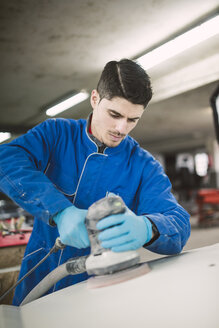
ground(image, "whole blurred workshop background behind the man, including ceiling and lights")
xmin=0 ymin=0 xmax=219 ymax=304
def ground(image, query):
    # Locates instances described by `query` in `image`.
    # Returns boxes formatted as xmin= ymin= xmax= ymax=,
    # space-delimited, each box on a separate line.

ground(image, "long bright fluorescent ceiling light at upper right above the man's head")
xmin=136 ymin=15 xmax=219 ymax=69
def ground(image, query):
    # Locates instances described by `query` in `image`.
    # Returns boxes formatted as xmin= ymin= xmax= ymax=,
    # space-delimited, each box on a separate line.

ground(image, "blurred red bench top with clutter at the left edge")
xmin=0 ymin=231 xmax=31 ymax=247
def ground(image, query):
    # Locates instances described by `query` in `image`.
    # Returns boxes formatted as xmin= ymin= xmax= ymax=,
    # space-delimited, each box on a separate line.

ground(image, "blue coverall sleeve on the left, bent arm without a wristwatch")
xmin=0 ymin=119 xmax=72 ymax=223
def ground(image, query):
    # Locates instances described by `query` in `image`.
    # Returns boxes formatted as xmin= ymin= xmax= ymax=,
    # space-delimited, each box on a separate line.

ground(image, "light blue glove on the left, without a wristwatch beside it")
xmin=53 ymin=206 xmax=90 ymax=248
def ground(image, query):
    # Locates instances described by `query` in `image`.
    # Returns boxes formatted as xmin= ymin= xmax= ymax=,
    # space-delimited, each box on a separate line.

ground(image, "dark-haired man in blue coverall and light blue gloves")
xmin=0 ymin=59 xmax=190 ymax=305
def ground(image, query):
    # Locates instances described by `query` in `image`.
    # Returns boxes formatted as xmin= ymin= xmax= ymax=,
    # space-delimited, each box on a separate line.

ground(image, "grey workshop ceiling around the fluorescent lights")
xmin=0 ymin=0 xmax=219 ymax=152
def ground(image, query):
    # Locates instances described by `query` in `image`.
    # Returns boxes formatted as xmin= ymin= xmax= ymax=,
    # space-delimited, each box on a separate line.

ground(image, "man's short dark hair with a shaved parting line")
xmin=97 ymin=59 xmax=152 ymax=107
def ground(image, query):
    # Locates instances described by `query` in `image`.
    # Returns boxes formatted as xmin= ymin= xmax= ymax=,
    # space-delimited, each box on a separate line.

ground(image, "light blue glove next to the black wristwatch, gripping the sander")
xmin=97 ymin=208 xmax=152 ymax=252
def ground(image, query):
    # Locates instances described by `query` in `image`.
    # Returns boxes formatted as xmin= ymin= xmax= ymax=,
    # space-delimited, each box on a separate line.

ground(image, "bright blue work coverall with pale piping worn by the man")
xmin=0 ymin=118 xmax=190 ymax=305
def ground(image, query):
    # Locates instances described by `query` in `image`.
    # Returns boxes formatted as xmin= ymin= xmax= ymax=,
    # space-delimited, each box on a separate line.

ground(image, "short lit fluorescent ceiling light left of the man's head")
xmin=46 ymin=91 xmax=89 ymax=116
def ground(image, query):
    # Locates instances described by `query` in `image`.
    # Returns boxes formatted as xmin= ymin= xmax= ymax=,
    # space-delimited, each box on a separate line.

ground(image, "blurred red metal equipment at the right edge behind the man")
xmin=196 ymin=189 xmax=219 ymax=223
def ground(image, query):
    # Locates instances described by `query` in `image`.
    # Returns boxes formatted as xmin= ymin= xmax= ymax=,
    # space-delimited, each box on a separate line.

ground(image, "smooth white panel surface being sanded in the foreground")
xmin=0 ymin=244 xmax=219 ymax=328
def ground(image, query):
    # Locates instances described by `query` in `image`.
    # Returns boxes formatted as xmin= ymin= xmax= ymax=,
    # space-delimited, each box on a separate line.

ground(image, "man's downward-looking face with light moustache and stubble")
xmin=91 ymin=90 xmax=144 ymax=147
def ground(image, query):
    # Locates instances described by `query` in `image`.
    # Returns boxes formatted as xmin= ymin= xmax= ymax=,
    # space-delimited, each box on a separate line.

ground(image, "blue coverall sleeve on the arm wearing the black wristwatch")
xmin=137 ymin=160 xmax=190 ymax=254
